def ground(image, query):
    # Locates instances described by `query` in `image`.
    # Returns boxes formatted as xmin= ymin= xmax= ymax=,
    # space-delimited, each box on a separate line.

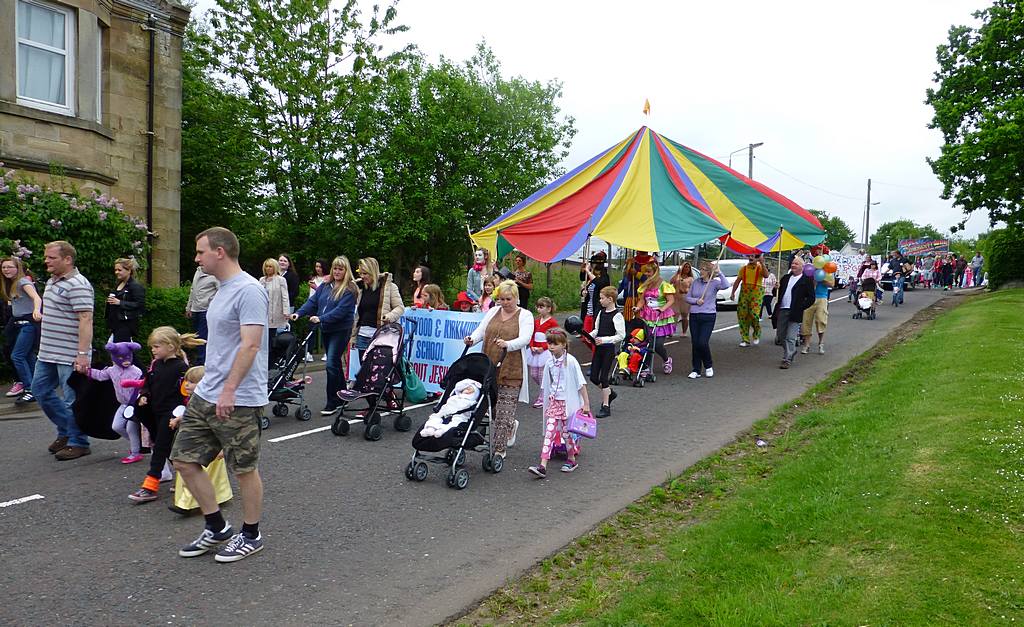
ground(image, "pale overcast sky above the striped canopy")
xmin=190 ymin=0 xmax=991 ymax=238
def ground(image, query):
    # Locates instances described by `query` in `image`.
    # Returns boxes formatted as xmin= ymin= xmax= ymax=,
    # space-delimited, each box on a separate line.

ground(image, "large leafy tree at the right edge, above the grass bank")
xmin=926 ymin=0 xmax=1024 ymax=232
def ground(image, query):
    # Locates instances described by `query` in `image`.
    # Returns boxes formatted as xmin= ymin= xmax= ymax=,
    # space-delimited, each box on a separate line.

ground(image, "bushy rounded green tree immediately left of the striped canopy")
xmin=351 ymin=44 xmax=575 ymax=284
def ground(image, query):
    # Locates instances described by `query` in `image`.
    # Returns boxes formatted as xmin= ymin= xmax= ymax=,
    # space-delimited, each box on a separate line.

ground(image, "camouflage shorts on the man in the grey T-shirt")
xmin=171 ymin=394 xmax=263 ymax=474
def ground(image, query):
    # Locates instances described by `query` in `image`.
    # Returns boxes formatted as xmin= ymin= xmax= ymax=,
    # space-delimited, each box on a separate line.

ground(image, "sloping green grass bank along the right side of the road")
xmin=457 ymin=290 xmax=1024 ymax=625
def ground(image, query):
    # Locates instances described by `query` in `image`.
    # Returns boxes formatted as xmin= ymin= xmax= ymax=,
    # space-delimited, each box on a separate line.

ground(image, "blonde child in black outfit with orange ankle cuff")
xmin=128 ymin=327 xmax=206 ymax=503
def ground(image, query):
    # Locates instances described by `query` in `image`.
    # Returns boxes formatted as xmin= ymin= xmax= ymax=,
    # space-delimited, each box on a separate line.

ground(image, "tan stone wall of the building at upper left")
xmin=0 ymin=0 xmax=188 ymax=287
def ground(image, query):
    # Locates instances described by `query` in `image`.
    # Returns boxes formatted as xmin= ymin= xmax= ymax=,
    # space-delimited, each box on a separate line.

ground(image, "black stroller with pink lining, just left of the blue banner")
xmin=331 ymin=323 xmax=413 ymax=442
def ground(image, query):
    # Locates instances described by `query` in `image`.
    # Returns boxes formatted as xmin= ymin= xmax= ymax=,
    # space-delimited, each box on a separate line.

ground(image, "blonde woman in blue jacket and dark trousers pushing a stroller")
xmin=292 ymin=255 xmax=358 ymax=416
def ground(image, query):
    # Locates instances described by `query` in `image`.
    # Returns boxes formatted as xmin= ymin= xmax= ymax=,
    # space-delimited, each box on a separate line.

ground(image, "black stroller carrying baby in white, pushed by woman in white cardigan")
xmin=406 ymin=346 xmax=505 ymax=490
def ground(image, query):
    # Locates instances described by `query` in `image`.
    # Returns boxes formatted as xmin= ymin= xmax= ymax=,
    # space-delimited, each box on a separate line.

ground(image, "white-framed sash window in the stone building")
xmin=16 ymin=0 xmax=75 ymax=115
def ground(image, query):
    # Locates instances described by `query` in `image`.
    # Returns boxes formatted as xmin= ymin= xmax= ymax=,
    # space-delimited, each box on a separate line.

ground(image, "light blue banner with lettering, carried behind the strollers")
xmin=348 ymin=309 xmax=483 ymax=392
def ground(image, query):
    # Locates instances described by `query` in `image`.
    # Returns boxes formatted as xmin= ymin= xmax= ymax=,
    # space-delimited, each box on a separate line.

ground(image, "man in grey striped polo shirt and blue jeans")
xmin=32 ymin=242 xmax=94 ymax=461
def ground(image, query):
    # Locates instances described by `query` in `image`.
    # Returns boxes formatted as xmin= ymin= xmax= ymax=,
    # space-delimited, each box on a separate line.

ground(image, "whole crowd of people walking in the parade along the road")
xmin=0 ymin=232 xmax=984 ymax=561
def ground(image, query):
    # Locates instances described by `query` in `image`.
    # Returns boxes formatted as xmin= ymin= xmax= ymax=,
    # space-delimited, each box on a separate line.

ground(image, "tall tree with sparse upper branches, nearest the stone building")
xmin=210 ymin=0 xmax=406 ymax=261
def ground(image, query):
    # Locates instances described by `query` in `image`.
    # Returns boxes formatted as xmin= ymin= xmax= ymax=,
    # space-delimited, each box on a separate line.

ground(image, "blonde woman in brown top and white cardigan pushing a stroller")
xmin=463 ymin=281 xmax=534 ymax=465
